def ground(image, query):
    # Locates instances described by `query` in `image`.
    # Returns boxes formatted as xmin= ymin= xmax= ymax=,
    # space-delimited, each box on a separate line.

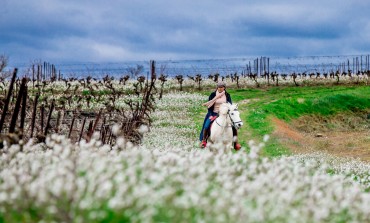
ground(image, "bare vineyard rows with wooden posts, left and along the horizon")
xmin=0 ymin=61 xmax=370 ymax=147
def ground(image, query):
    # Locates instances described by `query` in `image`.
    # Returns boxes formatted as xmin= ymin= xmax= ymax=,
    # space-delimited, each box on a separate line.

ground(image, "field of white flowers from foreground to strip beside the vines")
xmin=0 ymin=92 xmax=370 ymax=222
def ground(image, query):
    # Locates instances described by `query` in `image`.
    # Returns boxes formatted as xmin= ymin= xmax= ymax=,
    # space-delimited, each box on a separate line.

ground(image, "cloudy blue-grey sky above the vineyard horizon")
xmin=0 ymin=0 xmax=370 ymax=63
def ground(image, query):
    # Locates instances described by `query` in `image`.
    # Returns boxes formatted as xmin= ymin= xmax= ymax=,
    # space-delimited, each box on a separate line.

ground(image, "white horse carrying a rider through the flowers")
xmin=208 ymin=103 xmax=243 ymax=150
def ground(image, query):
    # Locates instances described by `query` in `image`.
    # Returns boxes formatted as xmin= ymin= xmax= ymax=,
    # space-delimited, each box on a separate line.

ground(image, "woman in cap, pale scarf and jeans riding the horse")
xmin=199 ymin=81 xmax=241 ymax=150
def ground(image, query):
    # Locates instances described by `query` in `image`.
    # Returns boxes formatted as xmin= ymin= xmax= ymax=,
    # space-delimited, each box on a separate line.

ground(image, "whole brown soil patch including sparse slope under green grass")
xmin=272 ymin=112 xmax=370 ymax=162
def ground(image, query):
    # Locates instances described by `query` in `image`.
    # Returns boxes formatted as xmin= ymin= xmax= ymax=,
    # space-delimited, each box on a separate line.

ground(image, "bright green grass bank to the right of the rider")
xmin=194 ymin=86 xmax=370 ymax=157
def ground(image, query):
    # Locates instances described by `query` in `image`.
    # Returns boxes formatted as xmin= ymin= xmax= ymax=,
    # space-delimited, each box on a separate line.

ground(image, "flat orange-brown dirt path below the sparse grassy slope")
xmin=271 ymin=118 xmax=370 ymax=162
